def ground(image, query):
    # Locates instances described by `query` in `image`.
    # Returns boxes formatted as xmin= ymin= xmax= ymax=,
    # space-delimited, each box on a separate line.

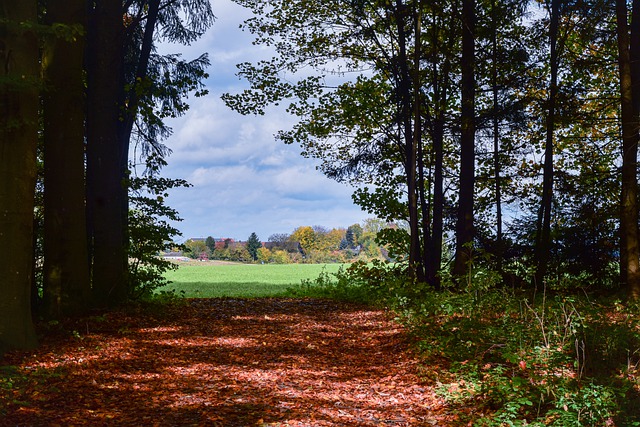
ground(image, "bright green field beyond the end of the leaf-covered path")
xmin=158 ymin=263 xmax=344 ymax=298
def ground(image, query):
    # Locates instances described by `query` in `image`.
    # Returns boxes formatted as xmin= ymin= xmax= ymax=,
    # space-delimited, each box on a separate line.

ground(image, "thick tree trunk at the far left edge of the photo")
xmin=0 ymin=0 xmax=39 ymax=354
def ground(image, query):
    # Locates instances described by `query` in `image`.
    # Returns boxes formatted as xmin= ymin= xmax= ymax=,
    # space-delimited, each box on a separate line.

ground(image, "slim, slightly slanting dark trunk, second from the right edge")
xmin=534 ymin=0 xmax=560 ymax=286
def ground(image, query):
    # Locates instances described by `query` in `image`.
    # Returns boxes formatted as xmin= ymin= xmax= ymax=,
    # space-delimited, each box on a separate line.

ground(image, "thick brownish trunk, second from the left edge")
xmin=42 ymin=0 xmax=91 ymax=318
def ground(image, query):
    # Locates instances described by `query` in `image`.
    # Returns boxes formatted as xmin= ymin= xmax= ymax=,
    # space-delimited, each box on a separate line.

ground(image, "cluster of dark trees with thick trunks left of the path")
xmin=0 ymin=0 xmax=214 ymax=351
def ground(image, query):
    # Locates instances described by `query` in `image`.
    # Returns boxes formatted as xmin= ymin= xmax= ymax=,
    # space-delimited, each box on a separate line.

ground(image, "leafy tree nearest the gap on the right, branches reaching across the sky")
xmin=224 ymin=0 xmax=440 ymax=281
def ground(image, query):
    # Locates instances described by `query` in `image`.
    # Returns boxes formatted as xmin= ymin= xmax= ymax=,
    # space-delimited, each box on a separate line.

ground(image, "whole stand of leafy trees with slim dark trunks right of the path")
xmin=224 ymin=0 xmax=640 ymax=298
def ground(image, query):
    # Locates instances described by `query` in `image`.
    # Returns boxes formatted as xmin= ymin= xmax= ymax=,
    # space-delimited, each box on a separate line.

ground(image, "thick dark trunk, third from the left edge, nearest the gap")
xmin=87 ymin=0 xmax=127 ymax=305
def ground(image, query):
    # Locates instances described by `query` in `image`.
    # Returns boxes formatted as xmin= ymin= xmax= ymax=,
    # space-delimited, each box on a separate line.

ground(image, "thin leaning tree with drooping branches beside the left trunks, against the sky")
xmin=114 ymin=0 xmax=214 ymax=290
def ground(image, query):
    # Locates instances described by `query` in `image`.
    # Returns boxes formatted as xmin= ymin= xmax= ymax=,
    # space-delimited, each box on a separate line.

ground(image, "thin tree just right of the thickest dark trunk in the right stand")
xmin=476 ymin=0 xmax=531 ymax=273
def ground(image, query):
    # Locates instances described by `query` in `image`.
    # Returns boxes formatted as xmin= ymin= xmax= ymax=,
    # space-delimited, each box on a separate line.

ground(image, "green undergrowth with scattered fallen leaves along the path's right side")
xmin=290 ymin=263 xmax=640 ymax=427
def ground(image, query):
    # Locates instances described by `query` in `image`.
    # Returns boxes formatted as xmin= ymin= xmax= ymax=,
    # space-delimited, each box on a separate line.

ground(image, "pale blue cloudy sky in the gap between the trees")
xmin=150 ymin=0 xmax=370 ymax=241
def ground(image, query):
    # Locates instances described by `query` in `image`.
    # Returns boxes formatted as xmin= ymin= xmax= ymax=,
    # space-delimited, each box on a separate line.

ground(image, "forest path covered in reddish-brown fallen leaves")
xmin=0 ymin=298 xmax=460 ymax=427
